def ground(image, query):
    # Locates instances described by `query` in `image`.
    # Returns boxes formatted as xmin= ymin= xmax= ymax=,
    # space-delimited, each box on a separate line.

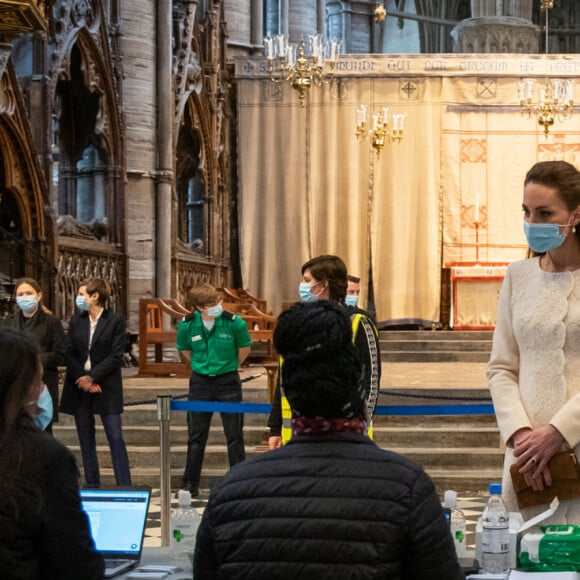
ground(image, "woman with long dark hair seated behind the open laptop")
xmin=0 ymin=328 xmax=103 ymax=580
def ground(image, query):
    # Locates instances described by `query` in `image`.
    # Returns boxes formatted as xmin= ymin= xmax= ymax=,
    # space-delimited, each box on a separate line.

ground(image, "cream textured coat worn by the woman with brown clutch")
xmin=487 ymin=258 xmax=580 ymax=523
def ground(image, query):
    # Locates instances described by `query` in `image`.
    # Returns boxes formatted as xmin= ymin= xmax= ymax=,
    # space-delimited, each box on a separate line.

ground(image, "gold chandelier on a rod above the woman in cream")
xmin=518 ymin=0 xmax=574 ymax=138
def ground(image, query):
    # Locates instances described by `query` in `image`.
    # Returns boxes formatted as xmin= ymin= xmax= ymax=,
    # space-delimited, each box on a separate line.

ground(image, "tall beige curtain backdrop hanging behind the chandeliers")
xmin=236 ymin=55 xmax=580 ymax=321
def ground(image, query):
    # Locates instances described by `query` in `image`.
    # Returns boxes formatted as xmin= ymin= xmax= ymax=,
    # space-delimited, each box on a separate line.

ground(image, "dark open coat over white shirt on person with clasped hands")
xmin=60 ymin=309 xmax=126 ymax=415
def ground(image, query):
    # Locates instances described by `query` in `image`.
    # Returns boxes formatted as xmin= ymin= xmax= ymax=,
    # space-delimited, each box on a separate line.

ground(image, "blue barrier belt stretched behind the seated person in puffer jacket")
xmin=170 ymin=400 xmax=494 ymax=415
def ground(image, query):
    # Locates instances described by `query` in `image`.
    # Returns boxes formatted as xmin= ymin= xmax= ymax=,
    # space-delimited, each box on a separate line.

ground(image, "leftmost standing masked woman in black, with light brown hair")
xmin=3 ymin=278 xmax=66 ymax=433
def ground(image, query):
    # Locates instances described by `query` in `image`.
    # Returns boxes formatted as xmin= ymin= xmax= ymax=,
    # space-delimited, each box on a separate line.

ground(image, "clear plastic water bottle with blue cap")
xmin=481 ymin=483 xmax=510 ymax=574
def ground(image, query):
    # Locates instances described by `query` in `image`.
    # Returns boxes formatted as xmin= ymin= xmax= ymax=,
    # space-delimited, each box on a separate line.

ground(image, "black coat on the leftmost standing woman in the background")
xmin=3 ymin=308 xmax=66 ymax=421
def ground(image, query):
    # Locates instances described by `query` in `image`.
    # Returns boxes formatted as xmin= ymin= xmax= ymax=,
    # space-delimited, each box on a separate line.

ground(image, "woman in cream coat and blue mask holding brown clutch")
xmin=487 ymin=161 xmax=580 ymax=523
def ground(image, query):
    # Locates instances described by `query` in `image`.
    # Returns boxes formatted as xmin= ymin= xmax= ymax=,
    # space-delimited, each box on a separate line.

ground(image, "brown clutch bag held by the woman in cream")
xmin=510 ymin=449 xmax=580 ymax=509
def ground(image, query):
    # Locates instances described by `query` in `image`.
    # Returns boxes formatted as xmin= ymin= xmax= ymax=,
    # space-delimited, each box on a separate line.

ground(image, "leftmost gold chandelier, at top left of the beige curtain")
xmin=264 ymin=34 xmax=342 ymax=107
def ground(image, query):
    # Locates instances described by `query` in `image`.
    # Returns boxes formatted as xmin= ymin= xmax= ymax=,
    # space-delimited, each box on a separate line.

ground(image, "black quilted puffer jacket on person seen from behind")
xmin=194 ymin=433 xmax=464 ymax=580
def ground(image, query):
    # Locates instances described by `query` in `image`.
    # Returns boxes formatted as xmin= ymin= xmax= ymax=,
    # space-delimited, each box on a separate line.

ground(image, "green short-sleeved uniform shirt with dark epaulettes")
xmin=176 ymin=311 xmax=252 ymax=375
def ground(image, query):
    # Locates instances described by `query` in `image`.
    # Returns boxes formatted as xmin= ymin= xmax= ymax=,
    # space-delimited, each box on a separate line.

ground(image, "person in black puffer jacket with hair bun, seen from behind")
xmin=193 ymin=300 xmax=464 ymax=580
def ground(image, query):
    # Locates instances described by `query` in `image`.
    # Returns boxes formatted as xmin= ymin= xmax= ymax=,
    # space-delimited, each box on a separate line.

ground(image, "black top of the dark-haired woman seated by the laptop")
xmin=0 ymin=418 xmax=103 ymax=580
